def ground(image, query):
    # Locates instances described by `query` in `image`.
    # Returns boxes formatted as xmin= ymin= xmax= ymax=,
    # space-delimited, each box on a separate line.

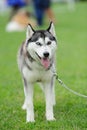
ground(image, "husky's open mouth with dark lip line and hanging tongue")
xmin=36 ymin=53 xmax=51 ymax=69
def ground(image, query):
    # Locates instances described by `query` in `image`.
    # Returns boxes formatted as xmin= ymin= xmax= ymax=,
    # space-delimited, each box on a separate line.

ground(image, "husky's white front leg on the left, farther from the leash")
xmin=23 ymin=79 xmax=34 ymax=122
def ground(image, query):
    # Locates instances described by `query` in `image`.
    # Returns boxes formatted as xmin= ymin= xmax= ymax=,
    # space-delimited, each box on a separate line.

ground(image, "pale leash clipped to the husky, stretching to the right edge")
xmin=52 ymin=71 xmax=87 ymax=98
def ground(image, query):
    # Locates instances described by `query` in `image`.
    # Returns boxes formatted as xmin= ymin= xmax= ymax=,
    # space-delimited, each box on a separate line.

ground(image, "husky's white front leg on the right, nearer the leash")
xmin=45 ymin=83 xmax=55 ymax=121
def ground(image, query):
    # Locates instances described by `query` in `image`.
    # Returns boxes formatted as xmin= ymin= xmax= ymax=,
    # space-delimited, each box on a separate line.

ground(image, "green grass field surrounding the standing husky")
xmin=0 ymin=2 xmax=87 ymax=130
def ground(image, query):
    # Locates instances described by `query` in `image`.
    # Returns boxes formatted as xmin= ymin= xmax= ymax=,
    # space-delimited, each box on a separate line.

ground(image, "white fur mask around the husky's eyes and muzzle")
xmin=28 ymin=37 xmax=56 ymax=59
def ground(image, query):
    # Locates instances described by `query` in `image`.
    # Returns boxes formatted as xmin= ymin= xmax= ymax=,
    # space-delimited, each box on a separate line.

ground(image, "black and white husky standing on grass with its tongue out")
xmin=18 ymin=22 xmax=57 ymax=122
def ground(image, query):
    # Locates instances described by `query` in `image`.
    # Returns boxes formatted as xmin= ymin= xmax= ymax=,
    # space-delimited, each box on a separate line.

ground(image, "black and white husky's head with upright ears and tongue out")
xmin=26 ymin=22 xmax=57 ymax=69
